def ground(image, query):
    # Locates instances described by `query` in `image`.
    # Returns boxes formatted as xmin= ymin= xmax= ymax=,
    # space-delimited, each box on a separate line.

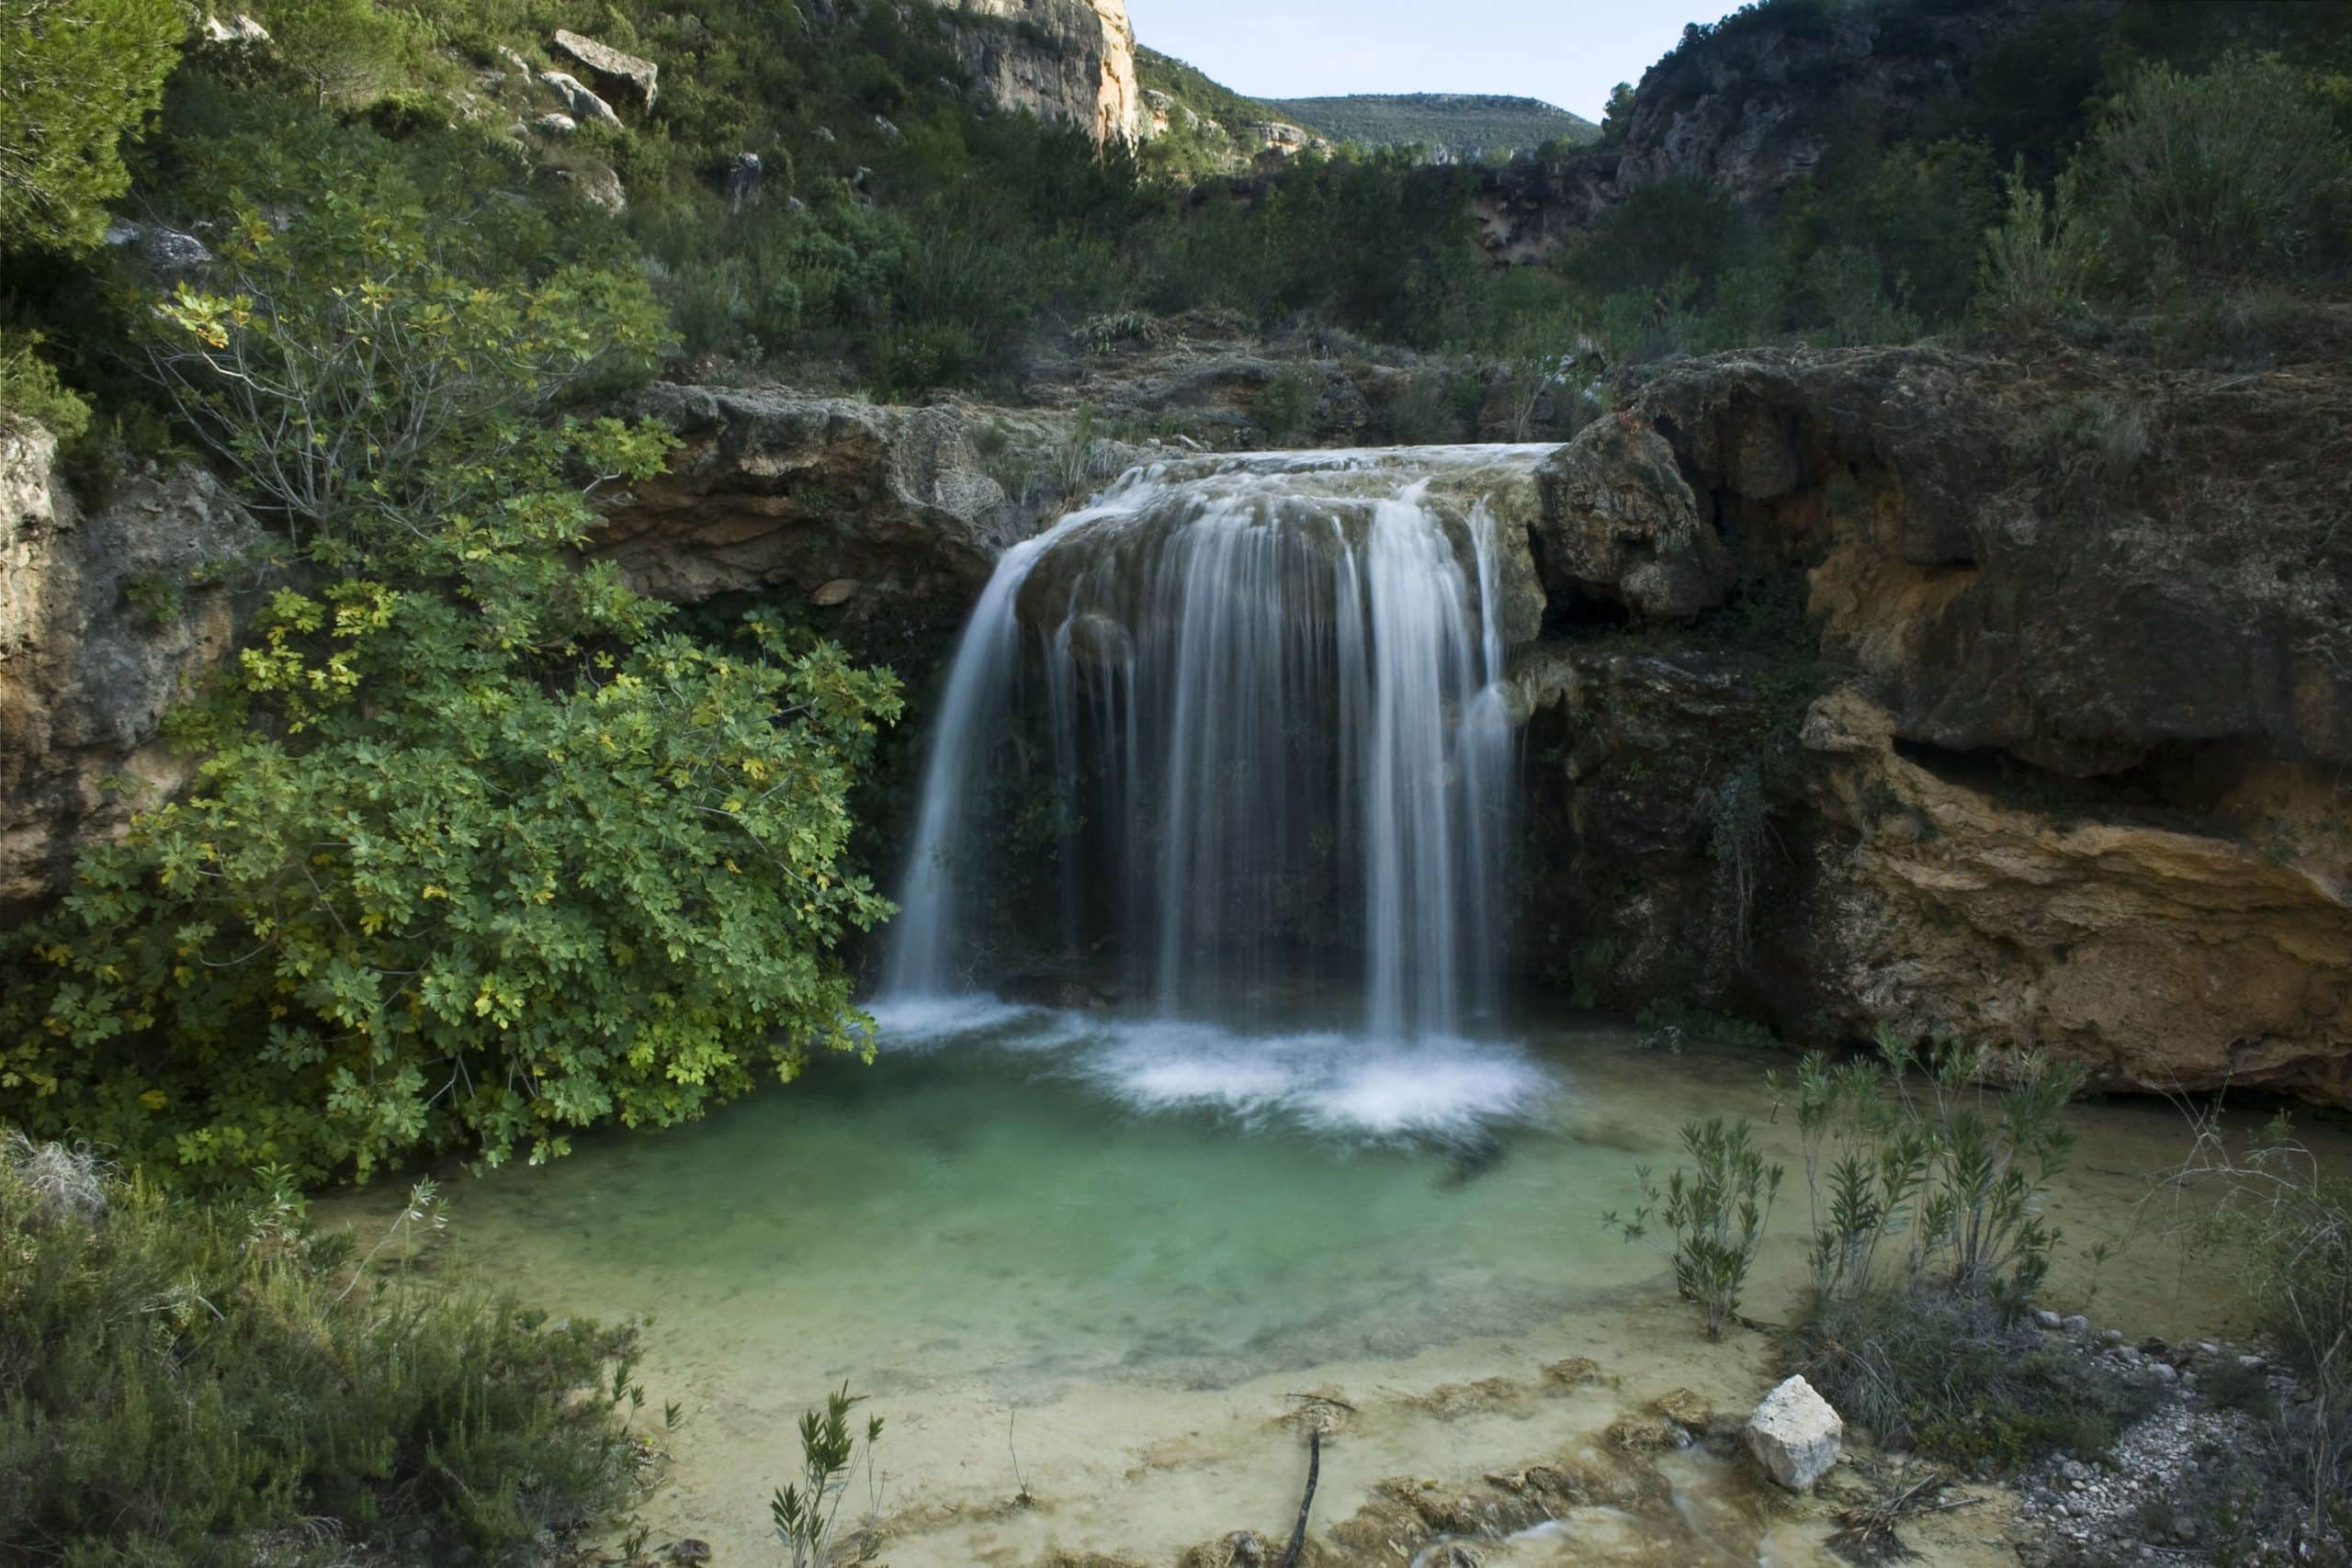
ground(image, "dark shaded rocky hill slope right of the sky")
xmin=1475 ymin=0 xmax=2120 ymax=264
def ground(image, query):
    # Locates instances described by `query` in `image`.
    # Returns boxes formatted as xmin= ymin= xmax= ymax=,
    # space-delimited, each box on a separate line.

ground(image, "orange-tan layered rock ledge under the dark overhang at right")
xmin=1802 ymin=689 xmax=2352 ymax=1105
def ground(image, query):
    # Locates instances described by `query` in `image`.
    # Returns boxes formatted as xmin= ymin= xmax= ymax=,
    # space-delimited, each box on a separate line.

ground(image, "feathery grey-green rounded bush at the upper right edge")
xmin=2079 ymin=54 xmax=2352 ymax=277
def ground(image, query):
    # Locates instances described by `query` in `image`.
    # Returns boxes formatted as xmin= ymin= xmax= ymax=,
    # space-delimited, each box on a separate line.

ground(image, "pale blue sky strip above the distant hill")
xmin=1126 ymin=0 xmax=1736 ymax=122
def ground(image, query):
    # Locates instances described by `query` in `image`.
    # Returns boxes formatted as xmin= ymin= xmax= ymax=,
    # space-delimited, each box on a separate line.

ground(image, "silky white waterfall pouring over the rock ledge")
xmin=882 ymin=446 xmax=1550 ymax=1039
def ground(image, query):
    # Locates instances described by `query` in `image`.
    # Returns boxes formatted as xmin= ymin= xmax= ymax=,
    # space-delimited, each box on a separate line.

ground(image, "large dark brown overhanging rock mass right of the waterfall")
xmin=1517 ymin=348 xmax=2352 ymax=1102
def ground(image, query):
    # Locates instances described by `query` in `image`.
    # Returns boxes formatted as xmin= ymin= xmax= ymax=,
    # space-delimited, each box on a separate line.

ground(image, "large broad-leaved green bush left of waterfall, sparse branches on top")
xmin=0 ymin=138 xmax=899 ymax=1180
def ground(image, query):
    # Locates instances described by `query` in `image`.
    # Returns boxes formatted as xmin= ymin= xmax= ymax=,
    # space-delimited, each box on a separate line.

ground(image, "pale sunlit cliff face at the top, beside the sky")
xmin=944 ymin=0 xmax=1150 ymax=146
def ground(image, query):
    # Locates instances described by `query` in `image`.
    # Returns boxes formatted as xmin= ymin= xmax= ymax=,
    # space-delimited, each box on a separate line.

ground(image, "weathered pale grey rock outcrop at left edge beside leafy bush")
xmin=0 ymin=425 xmax=259 ymax=917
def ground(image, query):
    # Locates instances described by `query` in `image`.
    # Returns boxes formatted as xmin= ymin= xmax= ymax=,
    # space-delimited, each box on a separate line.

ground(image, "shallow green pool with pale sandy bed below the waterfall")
xmin=332 ymin=1004 xmax=2352 ymax=1568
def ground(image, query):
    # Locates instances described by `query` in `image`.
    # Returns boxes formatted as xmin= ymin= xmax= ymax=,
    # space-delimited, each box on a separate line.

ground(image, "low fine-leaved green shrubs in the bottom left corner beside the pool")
xmin=0 ymin=1135 xmax=633 ymax=1568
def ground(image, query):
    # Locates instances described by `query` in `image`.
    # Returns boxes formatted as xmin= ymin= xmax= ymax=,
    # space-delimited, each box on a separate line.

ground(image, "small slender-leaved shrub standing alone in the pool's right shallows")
xmin=1604 ymin=1117 xmax=1782 ymax=1340
